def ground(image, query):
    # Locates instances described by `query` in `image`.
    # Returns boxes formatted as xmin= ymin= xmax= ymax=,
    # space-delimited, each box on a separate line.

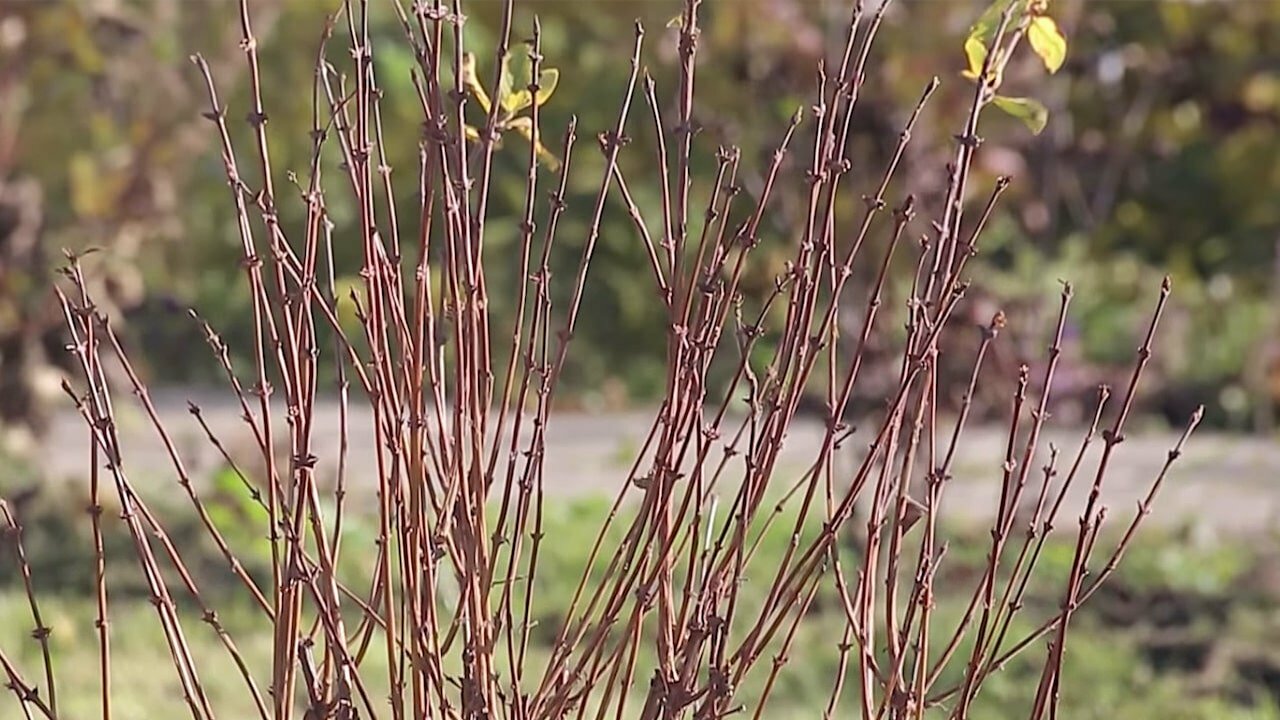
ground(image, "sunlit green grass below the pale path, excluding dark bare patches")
xmin=0 ymin=498 xmax=1280 ymax=720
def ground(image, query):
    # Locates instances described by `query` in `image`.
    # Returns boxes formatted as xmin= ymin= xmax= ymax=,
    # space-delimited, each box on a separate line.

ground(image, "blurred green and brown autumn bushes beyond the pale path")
xmin=0 ymin=0 xmax=1280 ymax=428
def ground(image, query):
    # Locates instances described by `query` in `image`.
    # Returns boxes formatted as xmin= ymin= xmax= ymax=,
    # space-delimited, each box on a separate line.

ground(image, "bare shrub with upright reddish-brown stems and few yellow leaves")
xmin=0 ymin=0 xmax=1198 ymax=720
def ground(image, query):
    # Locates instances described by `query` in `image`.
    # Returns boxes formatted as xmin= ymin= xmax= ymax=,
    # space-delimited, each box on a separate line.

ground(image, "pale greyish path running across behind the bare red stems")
xmin=27 ymin=391 xmax=1280 ymax=533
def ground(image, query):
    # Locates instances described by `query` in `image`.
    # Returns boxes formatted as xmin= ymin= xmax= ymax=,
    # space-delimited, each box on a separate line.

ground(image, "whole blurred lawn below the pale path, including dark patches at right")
xmin=0 ymin=489 xmax=1280 ymax=720
